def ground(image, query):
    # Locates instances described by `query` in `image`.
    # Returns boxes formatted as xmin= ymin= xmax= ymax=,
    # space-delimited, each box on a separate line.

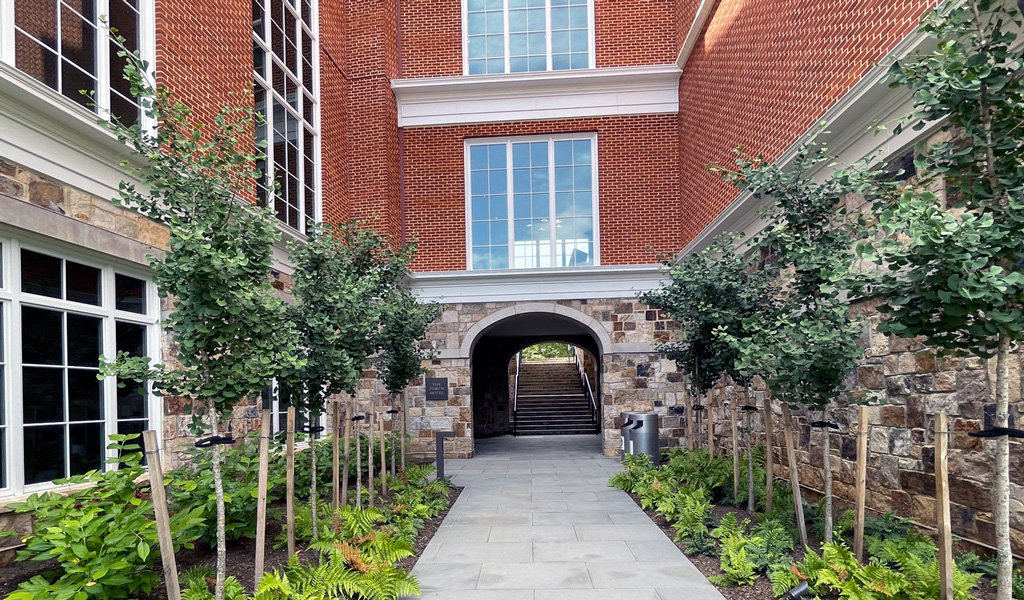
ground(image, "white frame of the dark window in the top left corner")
xmin=0 ymin=0 xmax=157 ymax=129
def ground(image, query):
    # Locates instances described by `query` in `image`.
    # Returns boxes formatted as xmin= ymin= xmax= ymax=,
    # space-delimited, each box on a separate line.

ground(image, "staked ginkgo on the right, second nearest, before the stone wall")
xmin=716 ymin=142 xmax=863 ymax=543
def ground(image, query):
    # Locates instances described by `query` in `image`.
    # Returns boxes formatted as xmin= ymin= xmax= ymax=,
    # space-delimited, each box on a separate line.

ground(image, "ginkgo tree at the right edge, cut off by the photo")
xmin=855 ymin=0 xmax=1024 ymax=600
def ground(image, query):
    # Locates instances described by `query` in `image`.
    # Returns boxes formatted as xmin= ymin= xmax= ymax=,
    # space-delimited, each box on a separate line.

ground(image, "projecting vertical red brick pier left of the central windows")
xmin=348 ymin=0 xmax=401 ymax=240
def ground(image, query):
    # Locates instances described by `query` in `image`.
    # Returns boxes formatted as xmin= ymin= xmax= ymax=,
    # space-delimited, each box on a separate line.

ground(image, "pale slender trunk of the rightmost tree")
xmin=992 ymin=334 xmax=1014 ymax=600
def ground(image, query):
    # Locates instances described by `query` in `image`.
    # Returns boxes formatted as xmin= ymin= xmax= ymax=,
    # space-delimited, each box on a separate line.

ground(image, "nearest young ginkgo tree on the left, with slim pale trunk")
xmin=102 ymin=46 xmax=301 ymax=600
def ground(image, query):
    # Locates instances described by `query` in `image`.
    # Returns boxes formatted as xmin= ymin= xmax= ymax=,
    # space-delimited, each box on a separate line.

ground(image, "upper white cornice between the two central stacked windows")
xmin=391 ymin=65 xmax=681 ymax=127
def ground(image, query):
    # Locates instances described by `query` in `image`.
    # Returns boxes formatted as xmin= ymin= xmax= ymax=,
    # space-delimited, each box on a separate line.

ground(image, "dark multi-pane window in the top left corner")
xmin=0 ymin=0 xmax=152 ymax=125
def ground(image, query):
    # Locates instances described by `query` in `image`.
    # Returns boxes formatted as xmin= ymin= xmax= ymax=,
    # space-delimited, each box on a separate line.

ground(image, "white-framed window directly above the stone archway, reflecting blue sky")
xmin=465 ymin=134 xmax=598 ymax=270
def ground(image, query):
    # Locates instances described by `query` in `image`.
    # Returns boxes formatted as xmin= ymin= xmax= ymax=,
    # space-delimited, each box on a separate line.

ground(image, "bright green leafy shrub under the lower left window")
xmin=7 ymin=435 xmax=203 ymax=600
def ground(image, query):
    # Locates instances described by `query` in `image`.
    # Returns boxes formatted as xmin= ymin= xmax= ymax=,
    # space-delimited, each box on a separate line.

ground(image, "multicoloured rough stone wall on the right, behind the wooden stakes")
xmin=680 ymin=296 xmax=1024 ymax=555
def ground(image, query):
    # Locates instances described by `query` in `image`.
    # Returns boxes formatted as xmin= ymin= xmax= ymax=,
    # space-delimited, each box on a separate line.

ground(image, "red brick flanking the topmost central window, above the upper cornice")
xmin=401 ymin=0 xmax=685 ymax=78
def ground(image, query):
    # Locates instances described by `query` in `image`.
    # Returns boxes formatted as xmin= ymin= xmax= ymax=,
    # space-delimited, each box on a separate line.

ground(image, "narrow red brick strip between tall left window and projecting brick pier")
xmin=319 ymin=0 xmax=351 ymax=223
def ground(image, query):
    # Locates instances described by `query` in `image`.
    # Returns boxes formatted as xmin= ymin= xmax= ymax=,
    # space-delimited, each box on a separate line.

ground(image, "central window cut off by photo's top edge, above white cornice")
xmin=463 ymin=0 xmax=594 ymax=75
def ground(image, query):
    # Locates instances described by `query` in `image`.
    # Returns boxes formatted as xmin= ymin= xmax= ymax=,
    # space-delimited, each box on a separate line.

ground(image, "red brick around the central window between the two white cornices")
xmin=403 ymin=115 xmax=684 ymax=271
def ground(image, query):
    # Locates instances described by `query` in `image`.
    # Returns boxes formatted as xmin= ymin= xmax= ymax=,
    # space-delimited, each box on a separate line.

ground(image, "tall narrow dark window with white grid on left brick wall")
xmin=252 ymin=0 xmax=321 ymax=232
